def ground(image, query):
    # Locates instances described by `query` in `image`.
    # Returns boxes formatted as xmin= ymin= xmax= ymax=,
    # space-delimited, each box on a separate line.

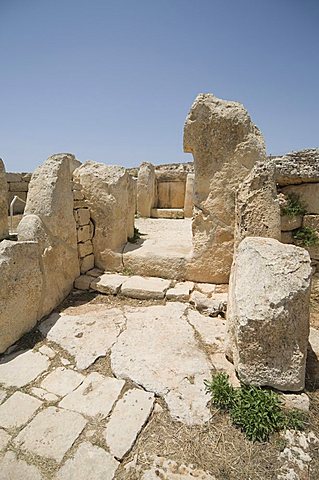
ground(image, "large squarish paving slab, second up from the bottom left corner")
xmin=14 ymin=407 xmax=87 ymax=462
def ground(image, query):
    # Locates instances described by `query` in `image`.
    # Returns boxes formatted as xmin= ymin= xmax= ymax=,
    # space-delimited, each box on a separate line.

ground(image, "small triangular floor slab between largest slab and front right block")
xmin=187 ymin=310 xmax=227 ymax=352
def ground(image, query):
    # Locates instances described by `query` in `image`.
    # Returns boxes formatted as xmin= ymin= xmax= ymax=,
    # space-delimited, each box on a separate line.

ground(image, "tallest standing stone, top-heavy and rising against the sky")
xmin=184 ymin=94 xmax=266 ymax=283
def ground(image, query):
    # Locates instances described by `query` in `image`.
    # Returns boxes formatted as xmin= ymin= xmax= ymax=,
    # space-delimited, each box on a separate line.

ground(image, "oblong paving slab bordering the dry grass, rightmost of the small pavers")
xmin=105 ymin=388 xmax=154 ymax=459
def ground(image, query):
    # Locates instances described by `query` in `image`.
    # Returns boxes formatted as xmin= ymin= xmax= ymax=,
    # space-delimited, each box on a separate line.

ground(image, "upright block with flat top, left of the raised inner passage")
xmin=74 ymin=162 xmax=134 ymax=271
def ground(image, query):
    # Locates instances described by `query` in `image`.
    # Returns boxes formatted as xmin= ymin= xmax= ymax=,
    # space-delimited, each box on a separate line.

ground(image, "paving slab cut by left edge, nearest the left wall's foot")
xmin=0 ymin=350 xmax=50 ymax=387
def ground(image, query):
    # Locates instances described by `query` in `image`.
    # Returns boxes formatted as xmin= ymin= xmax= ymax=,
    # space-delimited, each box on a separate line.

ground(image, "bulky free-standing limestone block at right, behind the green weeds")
xmin=227 ymin=237 xmax=311 ymax=391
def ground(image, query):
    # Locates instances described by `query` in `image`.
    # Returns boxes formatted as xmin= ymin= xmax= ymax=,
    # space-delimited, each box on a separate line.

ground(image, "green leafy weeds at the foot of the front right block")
xmin=205 ymin=372 xmax=304 ymax=442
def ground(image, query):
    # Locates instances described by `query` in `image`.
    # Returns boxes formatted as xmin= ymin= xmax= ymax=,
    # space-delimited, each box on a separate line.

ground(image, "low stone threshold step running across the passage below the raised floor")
xmin=74 ymin=268 xmax=228 ymax=313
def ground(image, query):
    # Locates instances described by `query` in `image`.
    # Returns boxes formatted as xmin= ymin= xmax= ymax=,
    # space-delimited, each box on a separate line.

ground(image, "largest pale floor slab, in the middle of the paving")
xmin=111 ymin=302 xmax=212 ymax=424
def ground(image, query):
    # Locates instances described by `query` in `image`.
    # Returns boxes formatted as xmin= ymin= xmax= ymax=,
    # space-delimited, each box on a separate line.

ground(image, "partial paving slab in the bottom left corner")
xmin=0 ymin=452 xmax=44 ymax=480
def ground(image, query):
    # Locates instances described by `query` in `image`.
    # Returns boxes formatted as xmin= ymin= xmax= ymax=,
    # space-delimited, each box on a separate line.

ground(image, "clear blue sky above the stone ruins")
xmin=0 ymin=0 xmax=319 ymax=171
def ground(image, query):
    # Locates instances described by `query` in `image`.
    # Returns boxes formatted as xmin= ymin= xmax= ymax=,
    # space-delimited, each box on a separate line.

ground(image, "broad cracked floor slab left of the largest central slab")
xmin=39 ymin=305 xmax=125 ymax=370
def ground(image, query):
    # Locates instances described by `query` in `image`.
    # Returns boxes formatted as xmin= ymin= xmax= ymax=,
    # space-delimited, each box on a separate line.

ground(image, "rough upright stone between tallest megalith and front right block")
xmin=235 ymin=162 xmax=281 ymax=246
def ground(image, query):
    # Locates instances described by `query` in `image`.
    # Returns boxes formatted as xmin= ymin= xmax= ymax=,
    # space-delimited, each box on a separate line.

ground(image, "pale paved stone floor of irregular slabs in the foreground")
xmin=0 ymin=285 xmax=319 ymax=480
